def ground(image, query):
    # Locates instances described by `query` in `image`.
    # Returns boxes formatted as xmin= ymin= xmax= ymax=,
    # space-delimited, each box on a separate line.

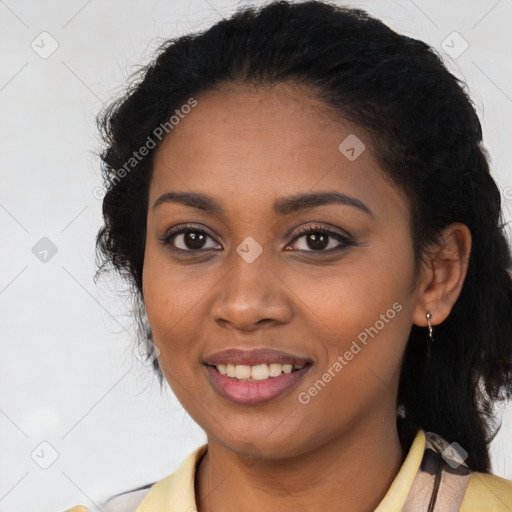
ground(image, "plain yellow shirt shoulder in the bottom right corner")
xmin=460 ymin=472 xmax=512 ymax=512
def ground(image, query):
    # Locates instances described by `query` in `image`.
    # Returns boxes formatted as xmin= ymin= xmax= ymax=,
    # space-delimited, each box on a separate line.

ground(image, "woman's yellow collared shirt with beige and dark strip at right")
xmin=67 ymin=424 xmax=512 ymax=512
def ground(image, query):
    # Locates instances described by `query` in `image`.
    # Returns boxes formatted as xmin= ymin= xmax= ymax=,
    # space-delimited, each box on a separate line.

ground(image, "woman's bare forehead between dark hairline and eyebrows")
xmin=150 ymin=84 xmax=408 ymax=218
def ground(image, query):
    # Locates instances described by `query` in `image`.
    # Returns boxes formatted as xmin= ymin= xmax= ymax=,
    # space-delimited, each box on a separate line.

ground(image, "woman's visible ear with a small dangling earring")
xmin=413 ymin=222 xmax=471 ymax=327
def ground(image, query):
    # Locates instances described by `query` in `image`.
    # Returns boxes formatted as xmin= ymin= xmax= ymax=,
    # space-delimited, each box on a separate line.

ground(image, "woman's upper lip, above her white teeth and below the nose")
xmin=204 ymin=348 xmax=311 ymax=366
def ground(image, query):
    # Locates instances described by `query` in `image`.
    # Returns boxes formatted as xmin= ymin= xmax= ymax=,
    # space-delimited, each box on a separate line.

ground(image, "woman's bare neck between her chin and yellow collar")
xmin=196 ymin=416 xmax=408 ymax=512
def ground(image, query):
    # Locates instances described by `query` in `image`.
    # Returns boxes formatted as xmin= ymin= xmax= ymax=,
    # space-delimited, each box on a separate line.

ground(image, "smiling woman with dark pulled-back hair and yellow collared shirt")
xmin=66 ymin=1 xmax=512 ymax=512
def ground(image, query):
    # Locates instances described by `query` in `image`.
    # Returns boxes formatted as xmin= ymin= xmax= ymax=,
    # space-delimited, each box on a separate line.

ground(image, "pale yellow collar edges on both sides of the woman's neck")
xmin=136 ymin=429 xmax=425 ymax=512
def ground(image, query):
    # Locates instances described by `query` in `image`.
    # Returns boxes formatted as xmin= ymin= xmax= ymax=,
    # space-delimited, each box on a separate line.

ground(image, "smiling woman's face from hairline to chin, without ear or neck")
xmin=143 ymin=84 xmax=419 ymax=458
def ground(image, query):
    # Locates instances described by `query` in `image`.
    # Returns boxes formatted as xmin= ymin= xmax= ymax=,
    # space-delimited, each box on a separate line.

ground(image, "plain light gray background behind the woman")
xmin=0 ymin=0 xmax=512 ymax=512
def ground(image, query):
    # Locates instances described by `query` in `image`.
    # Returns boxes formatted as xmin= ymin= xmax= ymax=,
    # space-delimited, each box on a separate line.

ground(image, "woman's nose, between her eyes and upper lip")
xmin=211 ymin=248 xmax=292 ymax=331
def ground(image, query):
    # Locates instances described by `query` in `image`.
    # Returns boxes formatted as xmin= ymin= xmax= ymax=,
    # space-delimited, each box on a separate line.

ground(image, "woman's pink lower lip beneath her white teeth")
xmin=206 ymin=364 xmax=311 ymax=405
